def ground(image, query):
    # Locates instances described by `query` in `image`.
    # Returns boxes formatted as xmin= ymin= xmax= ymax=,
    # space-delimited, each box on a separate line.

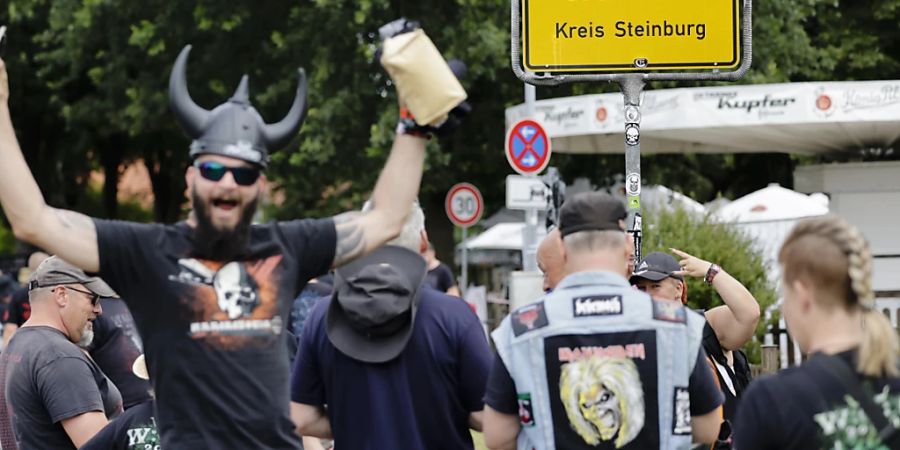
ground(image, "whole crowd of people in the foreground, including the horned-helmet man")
xmin=0 ymin=25 xmax=900 ymax=450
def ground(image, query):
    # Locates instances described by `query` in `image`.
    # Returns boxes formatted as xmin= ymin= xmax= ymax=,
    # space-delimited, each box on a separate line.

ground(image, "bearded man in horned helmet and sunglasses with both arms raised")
xmin=0 ymin=40 xmax=446 ymax=450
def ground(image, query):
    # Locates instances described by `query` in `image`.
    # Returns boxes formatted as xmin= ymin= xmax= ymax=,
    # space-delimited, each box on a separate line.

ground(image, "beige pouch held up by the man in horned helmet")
xmin=381 ymin=29 xmax=466 ymax=126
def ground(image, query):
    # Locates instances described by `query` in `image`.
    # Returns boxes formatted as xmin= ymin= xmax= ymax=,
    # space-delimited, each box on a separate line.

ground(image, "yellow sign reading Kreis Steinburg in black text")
xmin=522 ymin=0 xmax=740 ymax=72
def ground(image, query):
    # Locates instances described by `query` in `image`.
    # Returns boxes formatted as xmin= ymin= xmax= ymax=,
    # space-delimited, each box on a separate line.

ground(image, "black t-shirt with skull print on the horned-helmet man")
xmin=95 ymin=219 xmax=336 ymax=449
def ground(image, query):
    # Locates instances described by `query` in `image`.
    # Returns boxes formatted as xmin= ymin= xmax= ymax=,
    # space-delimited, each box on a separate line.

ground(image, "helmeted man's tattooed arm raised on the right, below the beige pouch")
xmin=332 ymin=134 xmax=425 ymax=267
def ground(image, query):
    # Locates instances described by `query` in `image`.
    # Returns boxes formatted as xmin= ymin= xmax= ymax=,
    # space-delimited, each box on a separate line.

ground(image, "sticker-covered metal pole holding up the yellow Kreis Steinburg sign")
xmin=619 ymin=74 xmax=644 ymax=264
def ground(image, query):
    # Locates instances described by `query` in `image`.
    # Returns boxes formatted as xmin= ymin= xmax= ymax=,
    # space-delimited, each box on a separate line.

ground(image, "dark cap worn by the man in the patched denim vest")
xmin=559 ymin=192 xmax=628 ymax=237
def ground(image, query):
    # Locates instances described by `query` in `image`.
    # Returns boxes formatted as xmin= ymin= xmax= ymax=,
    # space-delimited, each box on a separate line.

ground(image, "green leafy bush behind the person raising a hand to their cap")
xmin=642 ymin=209 xmax=778 ymax=363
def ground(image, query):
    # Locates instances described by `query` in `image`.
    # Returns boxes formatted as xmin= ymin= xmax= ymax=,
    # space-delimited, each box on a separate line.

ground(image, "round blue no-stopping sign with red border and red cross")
xmin=505 ymin=119 xmax=551 ymax=175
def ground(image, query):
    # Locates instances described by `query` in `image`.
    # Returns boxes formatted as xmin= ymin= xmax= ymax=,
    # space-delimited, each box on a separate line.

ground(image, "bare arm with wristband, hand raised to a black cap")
xmin=672 ymin=249 xmax=759 ymax=350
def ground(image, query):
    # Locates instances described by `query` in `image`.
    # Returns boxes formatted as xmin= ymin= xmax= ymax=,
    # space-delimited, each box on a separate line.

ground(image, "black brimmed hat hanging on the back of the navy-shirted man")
xmin=325 ymin=245 xmax=426 ymax=363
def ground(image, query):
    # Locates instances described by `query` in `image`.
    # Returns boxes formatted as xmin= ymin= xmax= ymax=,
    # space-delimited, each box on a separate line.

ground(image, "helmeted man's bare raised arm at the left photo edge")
xmin=0 ymin=59 xmax=100 ymax=272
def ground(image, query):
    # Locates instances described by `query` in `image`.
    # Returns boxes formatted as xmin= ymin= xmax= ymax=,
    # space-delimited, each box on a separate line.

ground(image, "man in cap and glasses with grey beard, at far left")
xmin=0 ymin=256 xmax=122 ymax=449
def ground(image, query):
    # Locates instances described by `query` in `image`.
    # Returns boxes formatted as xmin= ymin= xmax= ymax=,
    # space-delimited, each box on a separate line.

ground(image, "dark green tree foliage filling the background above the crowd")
xmin=0 ymin=0 xmax=900 ymax=253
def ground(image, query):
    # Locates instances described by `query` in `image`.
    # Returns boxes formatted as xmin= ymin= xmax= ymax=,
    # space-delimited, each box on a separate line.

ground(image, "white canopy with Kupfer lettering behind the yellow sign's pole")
xmin=506 ymin=80 xmax=900 ymax=154
